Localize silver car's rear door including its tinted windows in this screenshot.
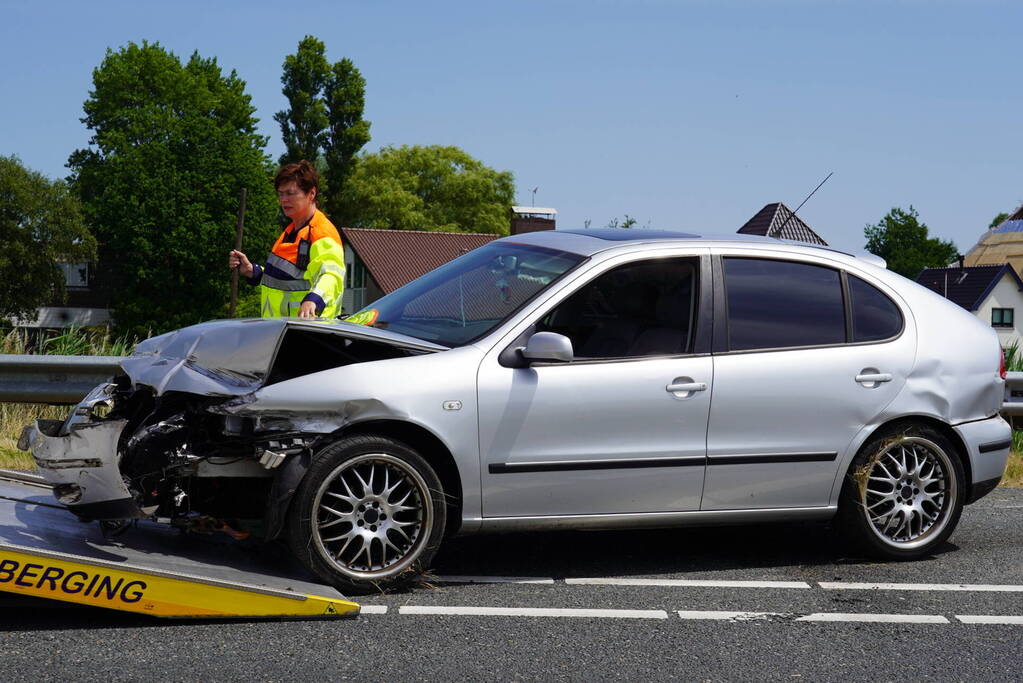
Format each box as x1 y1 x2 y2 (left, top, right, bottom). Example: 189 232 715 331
703 254 916 510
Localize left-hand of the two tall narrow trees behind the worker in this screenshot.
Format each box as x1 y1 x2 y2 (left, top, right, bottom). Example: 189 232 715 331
273 36 330 165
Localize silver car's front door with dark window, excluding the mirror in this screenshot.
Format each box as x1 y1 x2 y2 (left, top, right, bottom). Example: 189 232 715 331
478 257 712 517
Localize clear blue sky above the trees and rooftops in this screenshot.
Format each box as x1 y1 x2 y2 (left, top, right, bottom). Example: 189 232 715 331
0 0 1023 252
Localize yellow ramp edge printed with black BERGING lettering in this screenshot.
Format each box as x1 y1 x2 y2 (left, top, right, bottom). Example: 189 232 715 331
0 544 359 618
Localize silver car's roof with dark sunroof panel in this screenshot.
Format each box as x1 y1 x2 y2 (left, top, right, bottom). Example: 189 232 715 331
500 228 885 268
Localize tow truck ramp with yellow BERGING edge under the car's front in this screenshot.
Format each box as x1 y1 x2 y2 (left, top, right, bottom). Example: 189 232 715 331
0 470 359 619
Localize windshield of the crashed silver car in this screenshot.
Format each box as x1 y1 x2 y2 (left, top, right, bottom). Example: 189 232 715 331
346 242 583 347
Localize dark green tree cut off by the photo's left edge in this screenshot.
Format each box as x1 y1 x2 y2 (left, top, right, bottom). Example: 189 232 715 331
0 156 96 318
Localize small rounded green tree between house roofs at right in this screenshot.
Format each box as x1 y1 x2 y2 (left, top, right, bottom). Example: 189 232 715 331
863 206 959 279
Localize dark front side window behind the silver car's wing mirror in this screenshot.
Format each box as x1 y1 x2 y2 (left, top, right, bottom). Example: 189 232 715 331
537 259 698 359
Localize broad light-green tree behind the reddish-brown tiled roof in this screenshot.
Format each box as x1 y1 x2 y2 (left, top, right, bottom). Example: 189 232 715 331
344 145 515 235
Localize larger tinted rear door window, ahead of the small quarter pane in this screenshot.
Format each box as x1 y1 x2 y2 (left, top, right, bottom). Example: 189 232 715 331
724 258 846 351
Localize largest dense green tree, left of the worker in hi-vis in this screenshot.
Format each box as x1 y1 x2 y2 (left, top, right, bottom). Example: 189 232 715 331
68 42 277 334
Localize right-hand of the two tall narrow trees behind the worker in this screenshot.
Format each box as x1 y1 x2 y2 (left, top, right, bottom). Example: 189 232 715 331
323 58 369 225
